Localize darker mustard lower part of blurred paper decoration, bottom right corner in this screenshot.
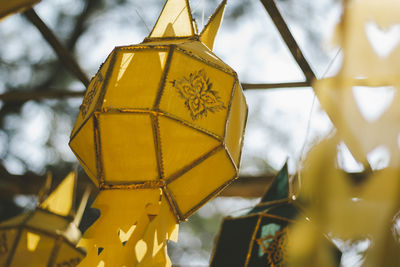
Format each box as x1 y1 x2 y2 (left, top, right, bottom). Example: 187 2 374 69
289 135 400 267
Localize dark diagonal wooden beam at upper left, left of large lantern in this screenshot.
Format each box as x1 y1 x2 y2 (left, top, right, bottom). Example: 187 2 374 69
24 8 89 87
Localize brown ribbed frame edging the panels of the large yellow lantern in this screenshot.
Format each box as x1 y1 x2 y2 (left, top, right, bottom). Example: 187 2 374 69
69 40 248 221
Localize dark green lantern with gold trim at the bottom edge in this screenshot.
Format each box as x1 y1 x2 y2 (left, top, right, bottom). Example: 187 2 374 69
210 164 341 267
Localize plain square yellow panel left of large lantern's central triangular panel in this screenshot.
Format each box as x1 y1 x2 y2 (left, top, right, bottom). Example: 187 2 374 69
99 113 159 182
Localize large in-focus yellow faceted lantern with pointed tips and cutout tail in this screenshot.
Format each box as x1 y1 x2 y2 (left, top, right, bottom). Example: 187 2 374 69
70 0 247 266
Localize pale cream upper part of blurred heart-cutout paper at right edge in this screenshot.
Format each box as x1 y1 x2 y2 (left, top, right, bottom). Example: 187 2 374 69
314 0 400 166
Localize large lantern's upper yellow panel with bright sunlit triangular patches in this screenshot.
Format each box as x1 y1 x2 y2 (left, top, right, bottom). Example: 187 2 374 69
103 50 168 109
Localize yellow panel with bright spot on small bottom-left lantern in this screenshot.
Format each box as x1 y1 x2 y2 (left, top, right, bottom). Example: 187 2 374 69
11 229 54 267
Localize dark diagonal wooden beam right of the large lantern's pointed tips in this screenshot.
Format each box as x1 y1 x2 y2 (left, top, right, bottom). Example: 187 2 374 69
260 0 315 82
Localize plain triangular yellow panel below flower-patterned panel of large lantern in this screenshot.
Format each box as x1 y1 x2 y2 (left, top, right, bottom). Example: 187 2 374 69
158 117 221 179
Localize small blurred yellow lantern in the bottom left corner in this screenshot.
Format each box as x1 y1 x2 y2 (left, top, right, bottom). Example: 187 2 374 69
0 173 86 267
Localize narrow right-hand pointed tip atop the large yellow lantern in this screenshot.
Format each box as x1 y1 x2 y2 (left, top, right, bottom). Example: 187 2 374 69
200 0 227 50
